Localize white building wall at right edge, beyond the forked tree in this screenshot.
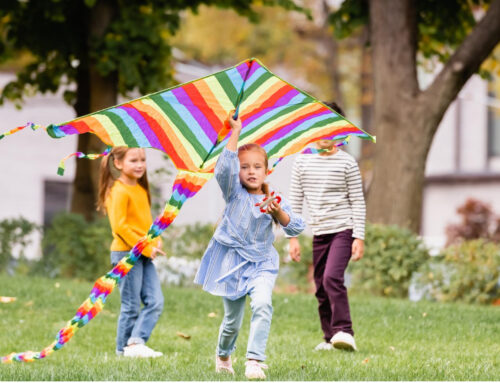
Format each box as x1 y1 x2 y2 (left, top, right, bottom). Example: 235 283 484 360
421 76 500 247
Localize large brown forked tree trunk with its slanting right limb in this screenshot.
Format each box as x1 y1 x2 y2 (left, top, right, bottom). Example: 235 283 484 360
368 0 500 232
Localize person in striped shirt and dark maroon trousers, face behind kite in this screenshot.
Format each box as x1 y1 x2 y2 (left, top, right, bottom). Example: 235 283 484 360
289 103 365 351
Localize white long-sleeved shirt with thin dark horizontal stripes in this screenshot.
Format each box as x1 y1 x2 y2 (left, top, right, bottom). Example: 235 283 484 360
289 149 366 239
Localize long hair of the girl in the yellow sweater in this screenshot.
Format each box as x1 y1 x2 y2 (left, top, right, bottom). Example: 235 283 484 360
97 146 151 214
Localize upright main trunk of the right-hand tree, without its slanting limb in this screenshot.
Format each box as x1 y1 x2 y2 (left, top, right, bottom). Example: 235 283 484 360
367 0 426 231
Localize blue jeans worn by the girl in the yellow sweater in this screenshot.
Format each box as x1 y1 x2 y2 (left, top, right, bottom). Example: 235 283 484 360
111 251 163 355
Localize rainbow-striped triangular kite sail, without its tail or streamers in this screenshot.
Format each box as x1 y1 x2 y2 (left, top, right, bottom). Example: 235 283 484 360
47 59 374 172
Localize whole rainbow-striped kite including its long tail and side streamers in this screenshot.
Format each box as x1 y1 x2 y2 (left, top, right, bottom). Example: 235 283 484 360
0 59 375 363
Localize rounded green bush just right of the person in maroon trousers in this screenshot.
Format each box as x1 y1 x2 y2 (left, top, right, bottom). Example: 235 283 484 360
348 224 429 298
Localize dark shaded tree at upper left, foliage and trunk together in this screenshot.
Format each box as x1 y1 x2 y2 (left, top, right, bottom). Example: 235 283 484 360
0 0 299 220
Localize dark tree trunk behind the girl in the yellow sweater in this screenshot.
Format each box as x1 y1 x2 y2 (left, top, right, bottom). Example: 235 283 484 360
71 2 118 221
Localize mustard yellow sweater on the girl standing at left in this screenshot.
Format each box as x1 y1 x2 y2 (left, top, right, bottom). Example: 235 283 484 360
105 180 158 257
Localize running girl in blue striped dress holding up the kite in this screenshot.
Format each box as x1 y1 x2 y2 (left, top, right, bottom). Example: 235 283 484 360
195 112 305 379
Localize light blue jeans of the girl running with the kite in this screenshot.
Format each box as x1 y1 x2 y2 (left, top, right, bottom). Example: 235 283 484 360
216 278 274 361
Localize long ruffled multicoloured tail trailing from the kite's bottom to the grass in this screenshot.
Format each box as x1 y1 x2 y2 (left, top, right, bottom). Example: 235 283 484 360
0 170 213 363
